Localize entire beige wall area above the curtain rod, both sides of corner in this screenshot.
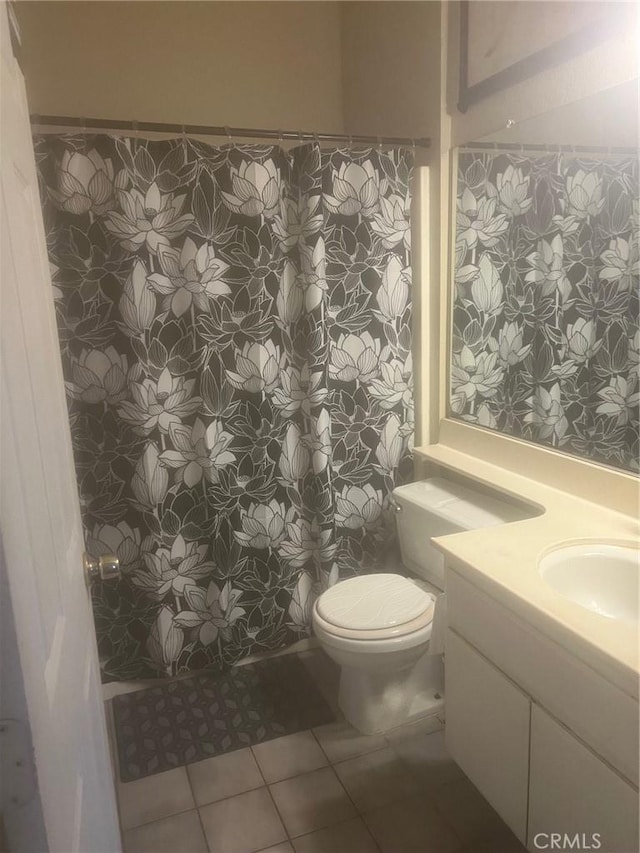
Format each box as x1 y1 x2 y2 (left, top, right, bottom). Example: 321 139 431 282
18 0 440 144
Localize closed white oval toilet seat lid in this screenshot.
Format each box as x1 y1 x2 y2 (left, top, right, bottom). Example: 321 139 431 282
316 574 434 633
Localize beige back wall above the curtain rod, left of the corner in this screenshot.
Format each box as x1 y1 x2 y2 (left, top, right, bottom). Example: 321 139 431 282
17 0 343 132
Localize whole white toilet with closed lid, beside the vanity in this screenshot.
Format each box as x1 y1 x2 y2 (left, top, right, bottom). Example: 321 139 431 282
313 479 526 734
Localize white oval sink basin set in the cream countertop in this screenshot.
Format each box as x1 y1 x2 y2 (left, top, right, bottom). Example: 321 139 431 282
538 544 640 623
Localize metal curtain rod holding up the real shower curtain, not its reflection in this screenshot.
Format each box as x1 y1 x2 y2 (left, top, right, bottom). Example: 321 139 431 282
31 114 431 148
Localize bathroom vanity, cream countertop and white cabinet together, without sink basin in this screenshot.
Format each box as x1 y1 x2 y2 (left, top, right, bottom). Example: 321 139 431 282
424 446 640 853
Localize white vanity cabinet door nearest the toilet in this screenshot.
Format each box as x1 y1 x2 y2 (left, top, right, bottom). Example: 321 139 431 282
445 629 531 843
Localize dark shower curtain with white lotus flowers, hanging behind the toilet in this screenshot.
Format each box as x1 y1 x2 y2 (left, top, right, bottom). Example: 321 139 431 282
36 136 413 679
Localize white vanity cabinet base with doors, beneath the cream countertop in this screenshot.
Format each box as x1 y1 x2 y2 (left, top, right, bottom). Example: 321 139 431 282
445 569 640 853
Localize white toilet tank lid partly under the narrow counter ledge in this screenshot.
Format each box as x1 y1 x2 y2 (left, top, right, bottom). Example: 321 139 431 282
393 477 527 530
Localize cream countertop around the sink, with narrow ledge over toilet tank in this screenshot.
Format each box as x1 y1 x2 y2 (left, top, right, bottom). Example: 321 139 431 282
416 444 640 698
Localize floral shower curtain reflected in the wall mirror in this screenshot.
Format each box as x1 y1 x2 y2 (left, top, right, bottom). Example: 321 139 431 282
450 148 640 470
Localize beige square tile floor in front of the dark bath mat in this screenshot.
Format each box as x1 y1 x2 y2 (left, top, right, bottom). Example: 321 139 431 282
110 651 524 853
